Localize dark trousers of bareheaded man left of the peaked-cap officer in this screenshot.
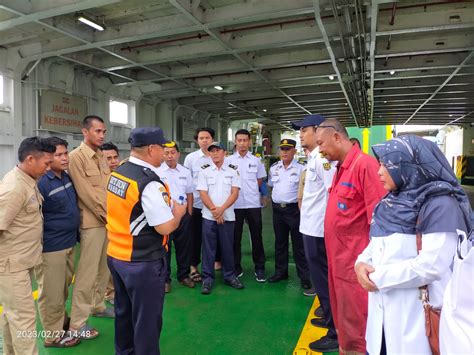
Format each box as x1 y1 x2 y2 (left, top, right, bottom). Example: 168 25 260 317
234 208 265 274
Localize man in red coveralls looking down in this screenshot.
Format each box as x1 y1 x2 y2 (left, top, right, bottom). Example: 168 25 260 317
314 119 386 354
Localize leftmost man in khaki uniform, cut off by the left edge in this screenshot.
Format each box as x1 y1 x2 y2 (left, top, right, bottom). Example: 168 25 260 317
0 137 55 355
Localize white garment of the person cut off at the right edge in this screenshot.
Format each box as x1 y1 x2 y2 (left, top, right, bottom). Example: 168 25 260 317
439 230 474 355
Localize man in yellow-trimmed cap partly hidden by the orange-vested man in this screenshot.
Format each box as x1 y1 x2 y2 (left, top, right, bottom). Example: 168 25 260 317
157 141 195 293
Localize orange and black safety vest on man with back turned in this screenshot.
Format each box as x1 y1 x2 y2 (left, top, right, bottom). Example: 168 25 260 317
107 161 171 262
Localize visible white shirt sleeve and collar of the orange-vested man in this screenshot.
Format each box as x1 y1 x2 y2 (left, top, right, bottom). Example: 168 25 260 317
128 157 174 227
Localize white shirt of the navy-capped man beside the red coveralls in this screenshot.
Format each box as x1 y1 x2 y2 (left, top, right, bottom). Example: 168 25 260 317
300 148 337 238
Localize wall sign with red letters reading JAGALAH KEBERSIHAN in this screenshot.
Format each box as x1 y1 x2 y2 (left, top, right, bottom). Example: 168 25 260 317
39 90 87 133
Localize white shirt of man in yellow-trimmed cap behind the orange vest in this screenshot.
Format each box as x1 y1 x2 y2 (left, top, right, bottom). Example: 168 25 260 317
158 163 194 201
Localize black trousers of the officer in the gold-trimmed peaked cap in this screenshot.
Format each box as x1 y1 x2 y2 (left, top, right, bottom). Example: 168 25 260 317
272 203 310 281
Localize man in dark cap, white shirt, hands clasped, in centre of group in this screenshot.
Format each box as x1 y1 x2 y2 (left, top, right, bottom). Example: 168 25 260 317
197 142 244 295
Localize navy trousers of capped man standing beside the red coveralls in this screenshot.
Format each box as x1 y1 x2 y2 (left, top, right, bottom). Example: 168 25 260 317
303 234 337 339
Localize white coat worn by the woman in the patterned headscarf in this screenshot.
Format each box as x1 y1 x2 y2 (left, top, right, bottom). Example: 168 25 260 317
354 233 458 354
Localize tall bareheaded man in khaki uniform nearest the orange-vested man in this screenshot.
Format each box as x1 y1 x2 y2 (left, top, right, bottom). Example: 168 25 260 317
69 116 114 339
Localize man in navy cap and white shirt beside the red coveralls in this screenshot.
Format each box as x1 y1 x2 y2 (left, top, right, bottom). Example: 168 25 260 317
293 115 338 352
